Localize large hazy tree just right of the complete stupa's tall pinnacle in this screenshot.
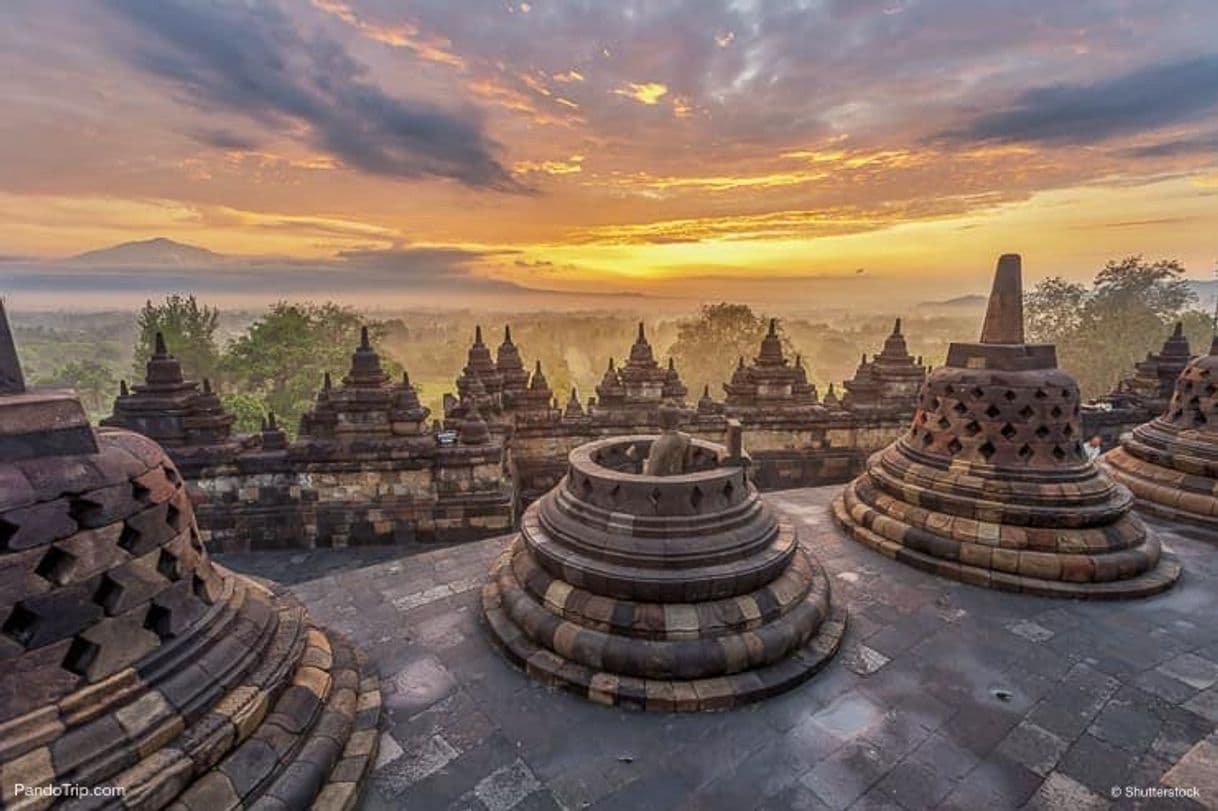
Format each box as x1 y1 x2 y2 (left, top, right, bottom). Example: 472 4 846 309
1024 256 1197 398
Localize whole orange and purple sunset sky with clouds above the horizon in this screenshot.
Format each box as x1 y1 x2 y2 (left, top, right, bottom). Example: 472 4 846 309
0 0 1218 304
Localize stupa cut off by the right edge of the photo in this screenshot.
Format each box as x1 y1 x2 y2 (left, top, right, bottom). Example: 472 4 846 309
1104 336 1218 528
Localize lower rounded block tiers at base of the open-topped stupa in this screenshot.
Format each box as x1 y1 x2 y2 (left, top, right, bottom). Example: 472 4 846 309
482 539 847 712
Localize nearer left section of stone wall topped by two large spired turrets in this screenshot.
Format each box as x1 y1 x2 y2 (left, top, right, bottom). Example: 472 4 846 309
104 335 515 552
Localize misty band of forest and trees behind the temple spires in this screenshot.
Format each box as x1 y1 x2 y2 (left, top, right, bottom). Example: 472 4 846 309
11 256 1213 431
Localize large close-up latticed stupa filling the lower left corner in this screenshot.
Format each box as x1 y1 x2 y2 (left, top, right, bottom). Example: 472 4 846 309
0 303 380 811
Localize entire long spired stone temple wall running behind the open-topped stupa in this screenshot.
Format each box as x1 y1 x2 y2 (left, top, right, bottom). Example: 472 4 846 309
104 323 924 552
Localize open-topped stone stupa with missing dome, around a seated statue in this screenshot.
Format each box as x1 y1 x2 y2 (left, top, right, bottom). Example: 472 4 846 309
482 427 845 711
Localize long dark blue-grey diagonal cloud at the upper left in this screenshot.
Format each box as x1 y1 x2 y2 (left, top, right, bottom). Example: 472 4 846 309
110 0 524 192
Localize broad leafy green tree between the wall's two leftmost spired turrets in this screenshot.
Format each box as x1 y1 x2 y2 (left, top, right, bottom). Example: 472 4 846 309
223 302 401 431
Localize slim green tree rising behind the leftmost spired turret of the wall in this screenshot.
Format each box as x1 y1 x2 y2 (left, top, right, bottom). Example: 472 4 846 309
133 293 220 380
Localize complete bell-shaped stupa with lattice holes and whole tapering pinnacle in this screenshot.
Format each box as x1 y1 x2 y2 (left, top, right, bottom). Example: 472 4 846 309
834 255 1180 598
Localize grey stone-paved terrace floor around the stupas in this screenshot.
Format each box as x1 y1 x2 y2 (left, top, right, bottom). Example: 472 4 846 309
224 488 1218 811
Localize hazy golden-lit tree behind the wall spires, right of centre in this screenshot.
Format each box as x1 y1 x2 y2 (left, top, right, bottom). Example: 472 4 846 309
661 302 793 398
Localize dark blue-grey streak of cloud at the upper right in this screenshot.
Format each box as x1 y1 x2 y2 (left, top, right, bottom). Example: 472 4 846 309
946 54 1218 145
